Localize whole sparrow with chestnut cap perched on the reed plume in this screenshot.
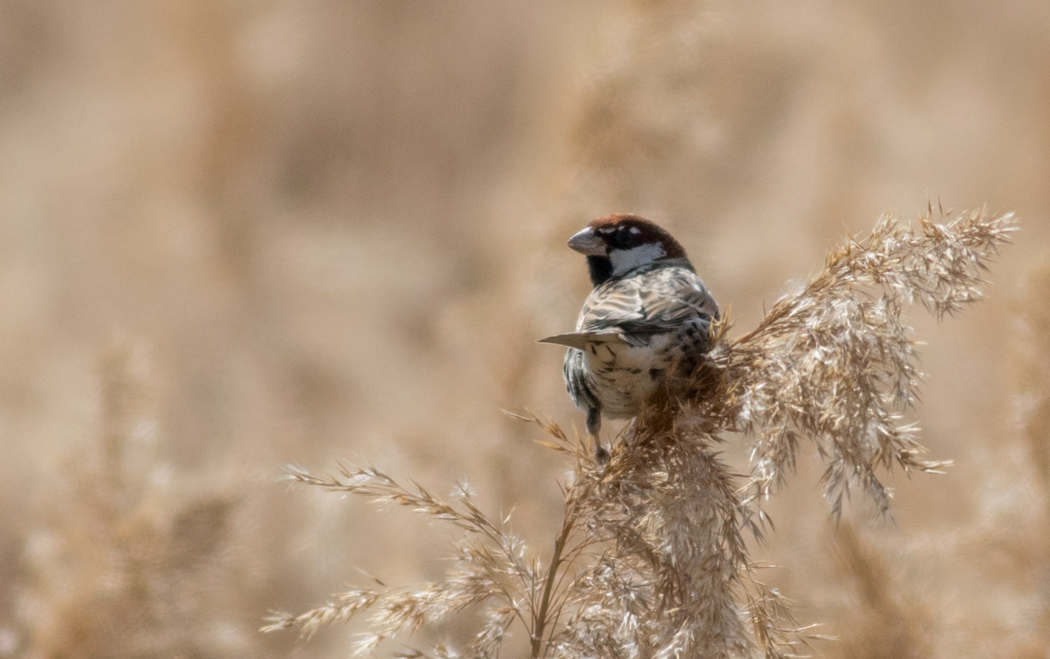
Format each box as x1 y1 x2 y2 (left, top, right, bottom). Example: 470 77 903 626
541 215 718 461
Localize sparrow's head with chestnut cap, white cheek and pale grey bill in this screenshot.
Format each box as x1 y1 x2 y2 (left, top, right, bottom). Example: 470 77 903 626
569 215 691 286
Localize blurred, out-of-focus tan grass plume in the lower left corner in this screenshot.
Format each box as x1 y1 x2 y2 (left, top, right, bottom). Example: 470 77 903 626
22 341 261 659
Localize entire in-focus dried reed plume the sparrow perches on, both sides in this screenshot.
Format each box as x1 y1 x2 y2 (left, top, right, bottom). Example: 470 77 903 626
265 209 1013 658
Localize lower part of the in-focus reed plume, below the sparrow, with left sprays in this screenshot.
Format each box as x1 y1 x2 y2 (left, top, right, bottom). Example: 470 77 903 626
264 418 794 659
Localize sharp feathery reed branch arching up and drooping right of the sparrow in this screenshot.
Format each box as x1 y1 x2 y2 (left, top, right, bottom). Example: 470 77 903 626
700 208 1015 515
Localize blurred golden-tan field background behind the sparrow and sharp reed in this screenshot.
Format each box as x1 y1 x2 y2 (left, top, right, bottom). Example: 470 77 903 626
0 0 1050 658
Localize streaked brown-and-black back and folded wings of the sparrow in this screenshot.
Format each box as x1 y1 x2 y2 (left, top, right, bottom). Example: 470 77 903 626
576 263 718 335
